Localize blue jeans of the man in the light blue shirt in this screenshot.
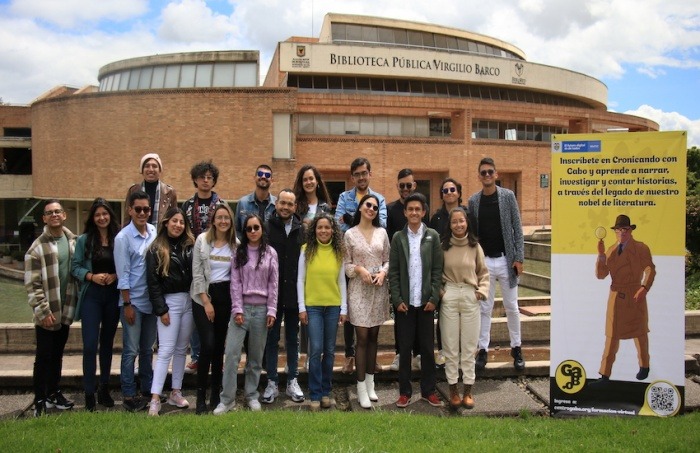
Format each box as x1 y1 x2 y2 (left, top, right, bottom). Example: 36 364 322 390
120 307 157 398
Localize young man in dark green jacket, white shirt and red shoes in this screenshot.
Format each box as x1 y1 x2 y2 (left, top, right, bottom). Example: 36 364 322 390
389 193 443 407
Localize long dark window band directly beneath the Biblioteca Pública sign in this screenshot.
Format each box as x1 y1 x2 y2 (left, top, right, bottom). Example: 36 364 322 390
287 74 592 109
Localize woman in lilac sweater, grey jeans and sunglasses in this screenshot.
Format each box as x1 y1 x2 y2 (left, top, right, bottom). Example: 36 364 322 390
214 214 279 415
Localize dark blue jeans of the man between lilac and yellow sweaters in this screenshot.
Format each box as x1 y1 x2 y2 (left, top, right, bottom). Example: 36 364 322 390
265 305 299 383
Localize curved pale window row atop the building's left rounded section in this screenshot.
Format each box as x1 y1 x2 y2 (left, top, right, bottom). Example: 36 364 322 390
100 62 258 91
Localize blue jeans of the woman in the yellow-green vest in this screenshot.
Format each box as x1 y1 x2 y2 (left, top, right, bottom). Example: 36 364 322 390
306 305 340 401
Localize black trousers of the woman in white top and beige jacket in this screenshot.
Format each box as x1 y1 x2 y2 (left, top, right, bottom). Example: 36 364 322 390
192 282 231 392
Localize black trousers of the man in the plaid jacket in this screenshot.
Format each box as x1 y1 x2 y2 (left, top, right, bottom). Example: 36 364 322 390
34 324 70 401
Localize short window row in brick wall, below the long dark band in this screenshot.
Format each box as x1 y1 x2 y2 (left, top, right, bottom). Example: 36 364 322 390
299 114 452 137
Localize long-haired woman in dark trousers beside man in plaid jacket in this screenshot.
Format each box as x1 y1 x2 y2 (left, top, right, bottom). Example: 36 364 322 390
71 198 119 412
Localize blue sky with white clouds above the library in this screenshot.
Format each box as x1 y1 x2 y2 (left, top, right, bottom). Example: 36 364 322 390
0 0 700 147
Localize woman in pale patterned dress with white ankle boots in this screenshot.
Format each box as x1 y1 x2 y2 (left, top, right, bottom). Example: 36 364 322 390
344 194 389 409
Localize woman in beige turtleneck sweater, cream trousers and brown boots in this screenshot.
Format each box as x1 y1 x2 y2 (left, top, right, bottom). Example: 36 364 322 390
440 207 489 409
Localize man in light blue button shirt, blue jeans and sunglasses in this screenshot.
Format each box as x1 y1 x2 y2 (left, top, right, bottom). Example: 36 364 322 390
114 191 157 412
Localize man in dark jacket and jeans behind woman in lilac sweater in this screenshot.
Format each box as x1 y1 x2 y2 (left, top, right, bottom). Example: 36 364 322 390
261 189 304 404
